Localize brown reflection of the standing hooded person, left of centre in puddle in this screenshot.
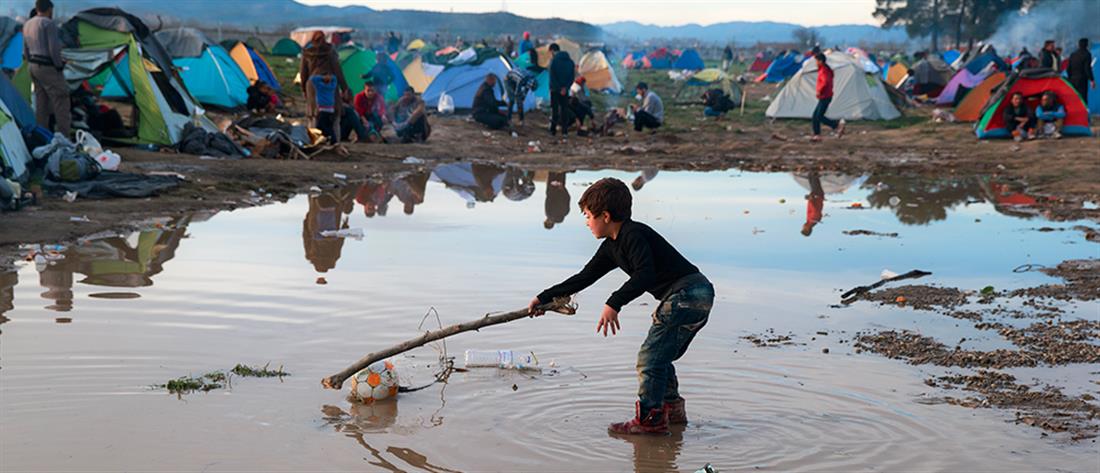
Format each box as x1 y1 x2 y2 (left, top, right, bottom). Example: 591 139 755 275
301 189 354 273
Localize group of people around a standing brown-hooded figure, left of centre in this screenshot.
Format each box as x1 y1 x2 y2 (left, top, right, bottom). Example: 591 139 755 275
298 32 431 143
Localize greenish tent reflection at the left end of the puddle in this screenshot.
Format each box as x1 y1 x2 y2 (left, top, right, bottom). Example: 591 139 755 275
39 216 193 312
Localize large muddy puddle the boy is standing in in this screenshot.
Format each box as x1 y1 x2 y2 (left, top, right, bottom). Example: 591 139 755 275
0 163 1100 472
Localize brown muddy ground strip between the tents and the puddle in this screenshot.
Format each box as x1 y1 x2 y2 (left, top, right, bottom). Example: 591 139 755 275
0 79 1100 268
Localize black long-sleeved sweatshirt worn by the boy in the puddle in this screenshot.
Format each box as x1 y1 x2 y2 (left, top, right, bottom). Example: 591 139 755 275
538 220 699 311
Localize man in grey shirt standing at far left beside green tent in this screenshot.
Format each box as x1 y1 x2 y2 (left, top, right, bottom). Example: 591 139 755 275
23 0 73 136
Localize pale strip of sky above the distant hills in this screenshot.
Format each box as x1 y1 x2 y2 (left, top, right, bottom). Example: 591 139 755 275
297 0 878 26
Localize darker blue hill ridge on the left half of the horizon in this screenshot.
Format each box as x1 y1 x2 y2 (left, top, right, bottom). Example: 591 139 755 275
0 0 603 41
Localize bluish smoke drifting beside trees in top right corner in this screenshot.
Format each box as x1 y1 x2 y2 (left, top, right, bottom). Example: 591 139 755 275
987 0 1100 55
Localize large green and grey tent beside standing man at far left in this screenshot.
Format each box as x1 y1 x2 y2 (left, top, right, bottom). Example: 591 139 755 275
62 8 217 145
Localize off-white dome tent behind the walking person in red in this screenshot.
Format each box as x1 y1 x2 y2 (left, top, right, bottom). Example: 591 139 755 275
766 52 901 120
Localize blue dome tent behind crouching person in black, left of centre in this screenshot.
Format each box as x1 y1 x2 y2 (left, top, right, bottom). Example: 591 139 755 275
422 56 541 110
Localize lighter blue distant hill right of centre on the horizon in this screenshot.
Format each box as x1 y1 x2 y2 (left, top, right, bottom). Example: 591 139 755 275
603 21 909 45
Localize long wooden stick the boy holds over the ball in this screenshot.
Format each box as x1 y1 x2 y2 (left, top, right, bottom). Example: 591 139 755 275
321 297 576 389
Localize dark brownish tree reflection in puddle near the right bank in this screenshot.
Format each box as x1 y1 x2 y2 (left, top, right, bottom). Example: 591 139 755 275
862 174 985 226
